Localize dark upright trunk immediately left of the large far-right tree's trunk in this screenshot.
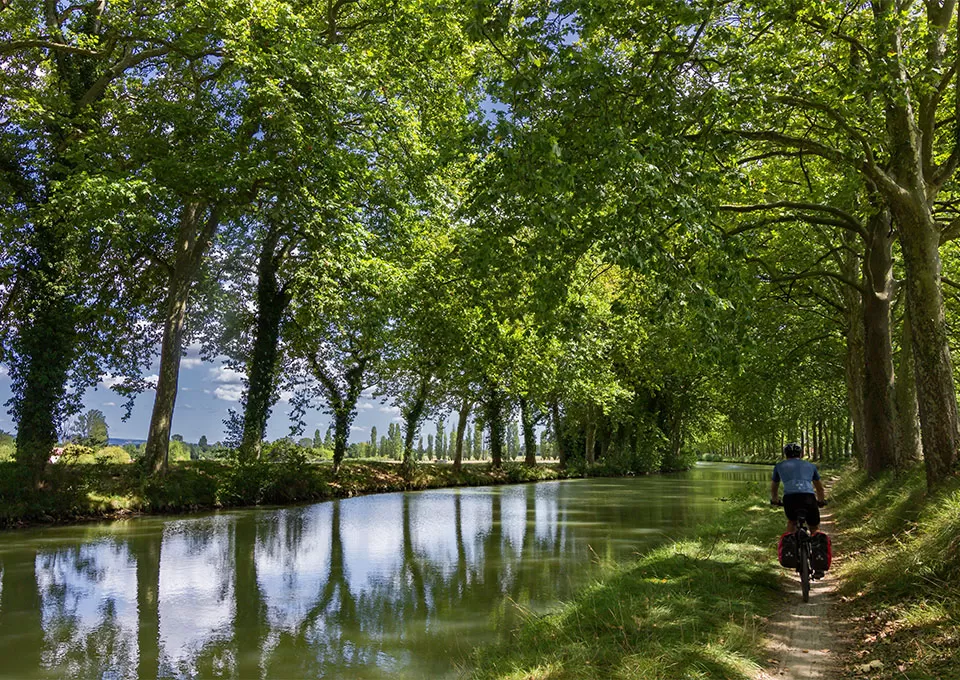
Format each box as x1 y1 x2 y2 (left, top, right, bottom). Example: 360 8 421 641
862 210 897 477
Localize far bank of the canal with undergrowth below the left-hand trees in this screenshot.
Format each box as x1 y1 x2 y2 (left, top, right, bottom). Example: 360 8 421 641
0 458 600 528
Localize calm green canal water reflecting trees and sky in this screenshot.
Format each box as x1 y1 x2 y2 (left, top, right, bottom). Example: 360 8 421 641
0 463 769 679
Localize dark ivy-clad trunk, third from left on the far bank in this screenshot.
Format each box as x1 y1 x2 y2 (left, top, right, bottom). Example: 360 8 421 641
240 225 290 460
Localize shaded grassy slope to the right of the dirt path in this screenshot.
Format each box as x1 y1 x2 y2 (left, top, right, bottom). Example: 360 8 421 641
833 469 960 680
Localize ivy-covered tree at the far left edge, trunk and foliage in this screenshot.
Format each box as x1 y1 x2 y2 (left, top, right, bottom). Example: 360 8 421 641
0 2 221 478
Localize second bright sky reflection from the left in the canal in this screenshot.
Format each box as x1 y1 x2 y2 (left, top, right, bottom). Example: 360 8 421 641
159 517 234 677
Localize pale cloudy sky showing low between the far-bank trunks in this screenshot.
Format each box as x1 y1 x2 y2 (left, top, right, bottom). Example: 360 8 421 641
0 346 428 443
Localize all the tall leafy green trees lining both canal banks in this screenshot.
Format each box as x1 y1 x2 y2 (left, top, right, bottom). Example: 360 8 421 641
0 0 960 485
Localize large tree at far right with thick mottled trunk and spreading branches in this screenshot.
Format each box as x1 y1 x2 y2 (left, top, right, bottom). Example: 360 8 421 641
705 0 960 486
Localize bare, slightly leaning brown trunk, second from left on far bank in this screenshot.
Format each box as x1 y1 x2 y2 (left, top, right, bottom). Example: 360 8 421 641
144 201 220 474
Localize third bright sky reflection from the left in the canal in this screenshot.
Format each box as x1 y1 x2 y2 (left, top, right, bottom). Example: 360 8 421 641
254 503 332 633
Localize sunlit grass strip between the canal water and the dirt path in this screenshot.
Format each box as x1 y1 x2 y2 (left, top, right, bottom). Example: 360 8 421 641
466 489 783 680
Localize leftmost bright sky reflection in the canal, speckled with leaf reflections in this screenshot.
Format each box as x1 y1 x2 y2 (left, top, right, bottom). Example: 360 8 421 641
35 539 138 677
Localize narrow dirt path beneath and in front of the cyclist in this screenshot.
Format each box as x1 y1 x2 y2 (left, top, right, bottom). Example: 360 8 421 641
756 514 840 680
